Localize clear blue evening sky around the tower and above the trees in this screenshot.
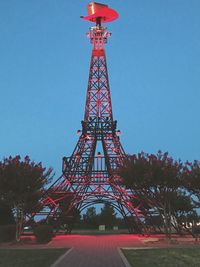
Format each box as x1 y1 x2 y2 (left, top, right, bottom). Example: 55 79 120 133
0 0 200 177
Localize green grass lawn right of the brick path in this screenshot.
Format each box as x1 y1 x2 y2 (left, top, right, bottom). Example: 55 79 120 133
122 247 200 267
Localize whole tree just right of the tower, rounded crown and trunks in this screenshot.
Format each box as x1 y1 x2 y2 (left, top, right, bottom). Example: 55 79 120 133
119 151 183 238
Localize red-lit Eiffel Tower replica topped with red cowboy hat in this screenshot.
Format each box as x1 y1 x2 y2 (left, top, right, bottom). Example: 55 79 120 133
34 2 148 233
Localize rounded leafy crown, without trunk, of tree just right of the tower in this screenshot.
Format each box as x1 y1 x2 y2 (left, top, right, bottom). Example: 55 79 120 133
119 151 183 192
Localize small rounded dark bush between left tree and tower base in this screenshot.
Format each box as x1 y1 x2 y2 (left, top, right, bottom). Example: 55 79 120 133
34 225 53 244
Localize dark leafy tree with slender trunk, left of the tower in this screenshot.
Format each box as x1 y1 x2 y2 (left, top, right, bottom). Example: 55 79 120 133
0 156 53 241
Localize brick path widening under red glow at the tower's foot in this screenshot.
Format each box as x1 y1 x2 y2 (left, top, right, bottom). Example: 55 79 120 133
49 235 144 267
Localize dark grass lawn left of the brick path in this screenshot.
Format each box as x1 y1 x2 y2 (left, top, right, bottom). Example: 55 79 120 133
0 249 67 267
